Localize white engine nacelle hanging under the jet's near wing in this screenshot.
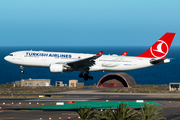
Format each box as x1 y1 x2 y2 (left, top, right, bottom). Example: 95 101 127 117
49 64 73 72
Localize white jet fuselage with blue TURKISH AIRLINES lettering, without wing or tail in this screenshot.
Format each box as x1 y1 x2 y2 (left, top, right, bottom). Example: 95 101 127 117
4 51 162 71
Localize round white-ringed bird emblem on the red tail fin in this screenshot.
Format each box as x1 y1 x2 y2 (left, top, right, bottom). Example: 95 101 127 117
150 40 169 58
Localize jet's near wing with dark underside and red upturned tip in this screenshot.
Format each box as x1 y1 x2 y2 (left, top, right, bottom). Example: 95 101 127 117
66 51 103 67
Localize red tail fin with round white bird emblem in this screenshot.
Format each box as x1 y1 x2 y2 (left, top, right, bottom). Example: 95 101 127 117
136 33 176 58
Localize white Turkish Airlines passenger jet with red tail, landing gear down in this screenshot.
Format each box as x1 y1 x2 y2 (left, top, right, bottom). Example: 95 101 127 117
4 32 175 81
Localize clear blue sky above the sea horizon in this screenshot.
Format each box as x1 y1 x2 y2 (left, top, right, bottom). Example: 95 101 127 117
0 0 180 46
